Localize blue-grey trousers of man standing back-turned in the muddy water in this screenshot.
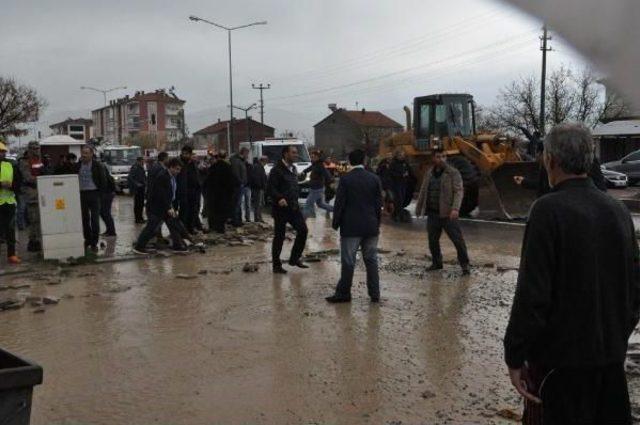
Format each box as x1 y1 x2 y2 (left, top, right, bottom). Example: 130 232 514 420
336 236 380 298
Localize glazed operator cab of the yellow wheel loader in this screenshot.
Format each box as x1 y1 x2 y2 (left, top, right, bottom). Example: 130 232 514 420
413 94 475 149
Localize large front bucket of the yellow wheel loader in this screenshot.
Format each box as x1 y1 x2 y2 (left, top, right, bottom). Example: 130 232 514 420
478 161 540 220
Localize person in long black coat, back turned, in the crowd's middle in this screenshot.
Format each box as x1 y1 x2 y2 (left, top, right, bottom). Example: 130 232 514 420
205 151 238 233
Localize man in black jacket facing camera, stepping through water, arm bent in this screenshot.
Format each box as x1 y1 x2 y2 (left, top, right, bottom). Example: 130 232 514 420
267 145 309 274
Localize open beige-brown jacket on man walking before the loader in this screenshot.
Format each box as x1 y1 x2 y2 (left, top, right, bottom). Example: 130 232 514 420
416 164 464 218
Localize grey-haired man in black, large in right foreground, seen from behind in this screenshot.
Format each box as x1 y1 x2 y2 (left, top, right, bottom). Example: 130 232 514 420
504 124 640 425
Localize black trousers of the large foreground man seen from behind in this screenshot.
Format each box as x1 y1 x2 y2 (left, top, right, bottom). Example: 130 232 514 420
541 363 631 425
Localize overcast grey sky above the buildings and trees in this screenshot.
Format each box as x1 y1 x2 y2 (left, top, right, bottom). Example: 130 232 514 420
0 0 584 136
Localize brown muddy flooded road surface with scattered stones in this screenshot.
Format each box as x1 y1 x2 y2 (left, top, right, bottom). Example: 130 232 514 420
0 210 637 425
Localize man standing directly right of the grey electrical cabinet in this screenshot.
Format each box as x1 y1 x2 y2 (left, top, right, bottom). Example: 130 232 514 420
76 145 106 252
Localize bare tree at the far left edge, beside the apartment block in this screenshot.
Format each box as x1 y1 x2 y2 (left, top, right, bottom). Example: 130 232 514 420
0 77 46 131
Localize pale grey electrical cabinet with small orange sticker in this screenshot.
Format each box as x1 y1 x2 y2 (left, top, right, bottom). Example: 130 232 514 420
38 174 84 260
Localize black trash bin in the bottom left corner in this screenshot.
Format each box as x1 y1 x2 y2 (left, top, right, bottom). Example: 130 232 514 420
0 348 42 425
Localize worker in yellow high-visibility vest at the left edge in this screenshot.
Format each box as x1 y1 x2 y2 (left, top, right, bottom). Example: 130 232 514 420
0 141 20 264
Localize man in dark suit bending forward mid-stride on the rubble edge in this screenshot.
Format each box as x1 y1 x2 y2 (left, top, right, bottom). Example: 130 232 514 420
133 158 186 255
